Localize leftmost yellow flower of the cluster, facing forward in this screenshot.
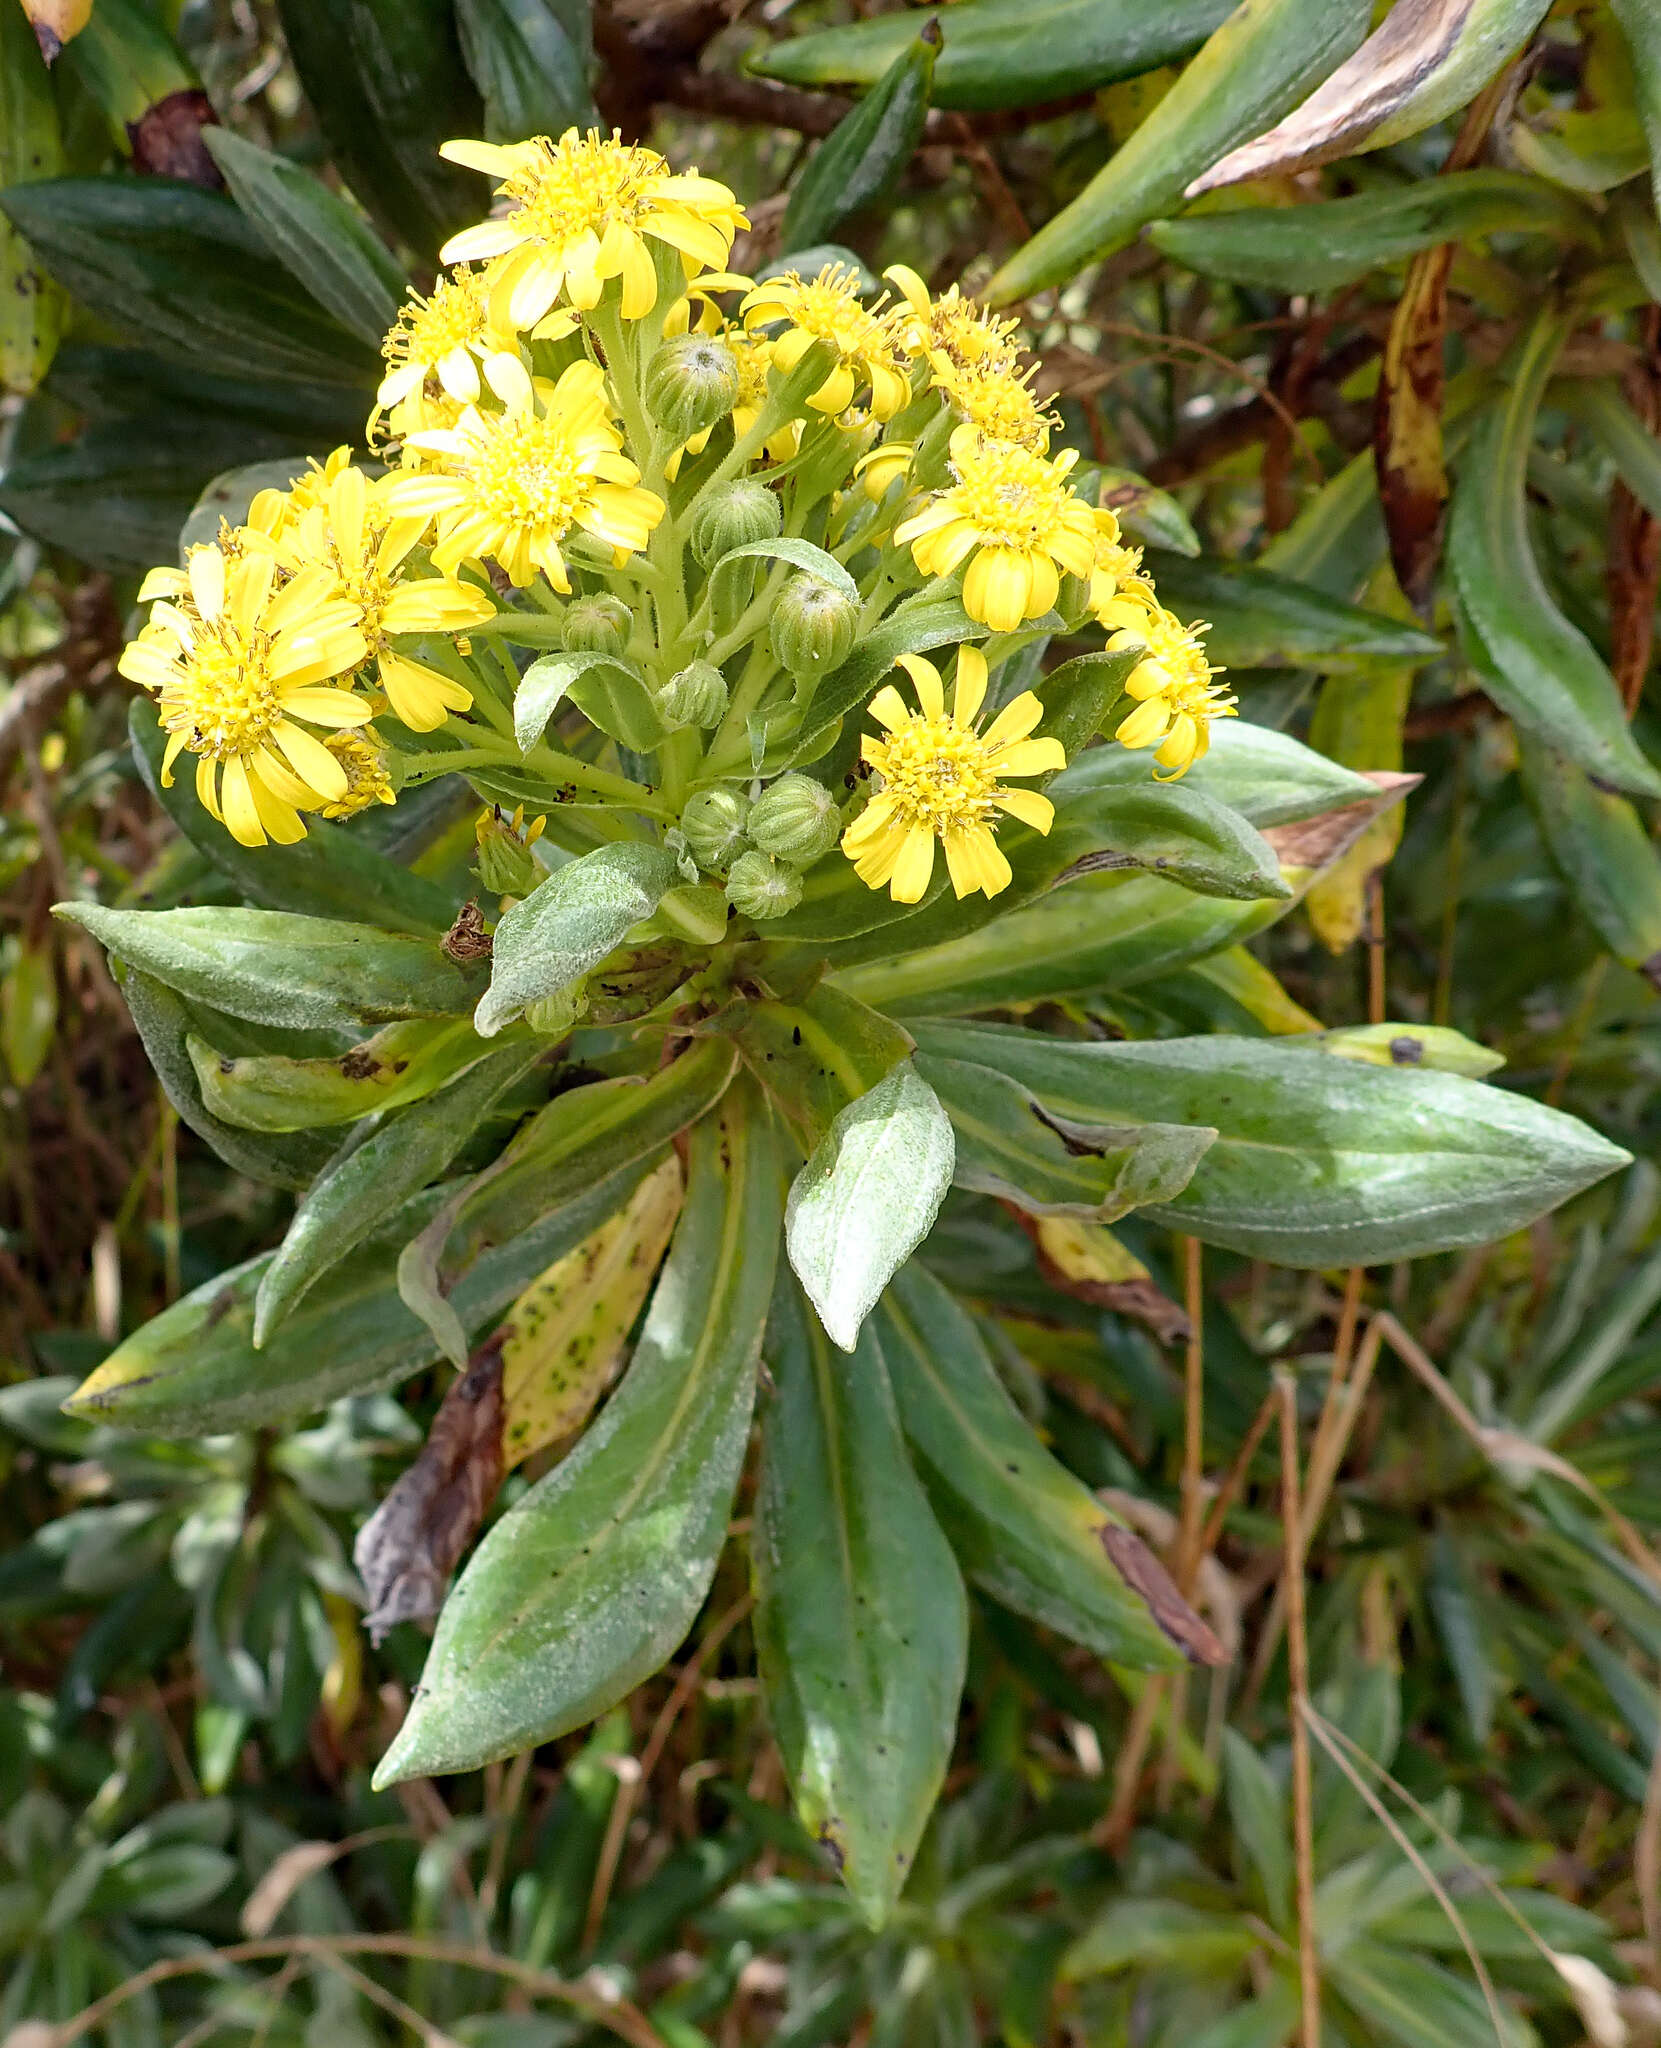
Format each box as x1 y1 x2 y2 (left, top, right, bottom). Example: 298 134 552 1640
121 547 371 846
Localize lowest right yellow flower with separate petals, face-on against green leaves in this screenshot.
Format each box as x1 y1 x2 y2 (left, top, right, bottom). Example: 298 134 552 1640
842 647 1067 903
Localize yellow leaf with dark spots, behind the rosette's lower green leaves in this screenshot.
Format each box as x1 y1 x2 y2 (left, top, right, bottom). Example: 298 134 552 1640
498 1153 686 1470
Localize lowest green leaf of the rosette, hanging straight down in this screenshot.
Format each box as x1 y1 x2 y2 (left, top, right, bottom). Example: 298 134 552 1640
752 1278 969 1927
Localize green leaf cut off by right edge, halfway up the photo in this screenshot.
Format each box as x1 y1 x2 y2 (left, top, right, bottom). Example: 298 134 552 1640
1520 735 1661 987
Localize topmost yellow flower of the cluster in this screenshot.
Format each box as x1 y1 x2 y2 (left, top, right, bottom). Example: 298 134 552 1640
438 129 750 330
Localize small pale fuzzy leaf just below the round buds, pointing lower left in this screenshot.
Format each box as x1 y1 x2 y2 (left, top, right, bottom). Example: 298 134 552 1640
473 844 680 1038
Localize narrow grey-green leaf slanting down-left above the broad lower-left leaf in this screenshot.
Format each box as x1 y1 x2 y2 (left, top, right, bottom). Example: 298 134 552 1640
254 1042 543 1350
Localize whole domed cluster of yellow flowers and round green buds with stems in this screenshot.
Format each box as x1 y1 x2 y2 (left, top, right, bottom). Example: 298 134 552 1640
121 129 1233 897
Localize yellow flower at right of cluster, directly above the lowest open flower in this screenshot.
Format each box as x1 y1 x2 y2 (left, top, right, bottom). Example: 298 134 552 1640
895 426 1102 633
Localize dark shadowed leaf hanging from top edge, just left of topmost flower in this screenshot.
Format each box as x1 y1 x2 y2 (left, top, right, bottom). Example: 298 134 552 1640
276 0 485 260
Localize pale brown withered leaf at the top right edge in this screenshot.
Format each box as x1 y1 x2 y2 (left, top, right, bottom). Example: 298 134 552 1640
1188 0 1550 199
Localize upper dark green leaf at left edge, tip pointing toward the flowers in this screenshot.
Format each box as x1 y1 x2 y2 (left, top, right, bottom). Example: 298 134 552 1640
0 178 377 389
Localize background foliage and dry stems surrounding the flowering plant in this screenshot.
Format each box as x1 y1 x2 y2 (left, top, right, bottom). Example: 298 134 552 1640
0 0 1661 2048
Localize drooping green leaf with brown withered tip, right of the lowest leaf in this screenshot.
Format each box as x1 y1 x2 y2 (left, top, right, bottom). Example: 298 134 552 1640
872 1266 1221 1671
